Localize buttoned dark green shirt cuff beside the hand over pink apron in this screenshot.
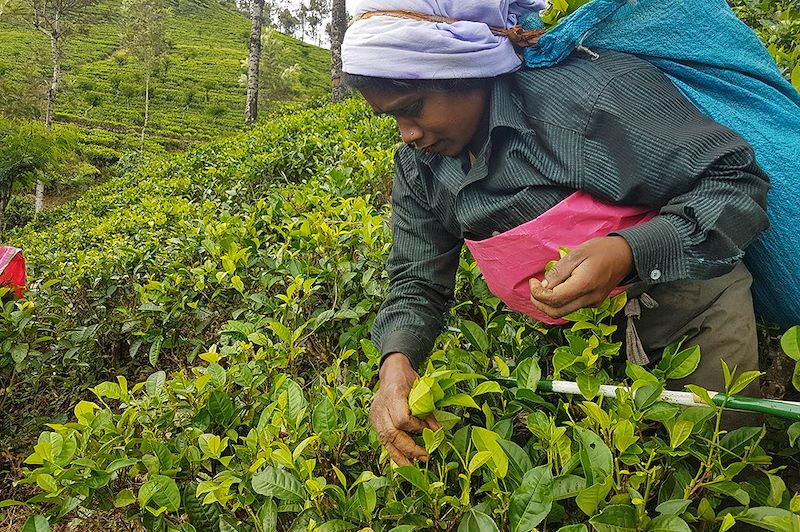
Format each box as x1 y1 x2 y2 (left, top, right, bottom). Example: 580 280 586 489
611 216 687 285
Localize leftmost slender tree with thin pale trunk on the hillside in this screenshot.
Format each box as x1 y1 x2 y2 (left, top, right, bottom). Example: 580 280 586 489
17 0 98 213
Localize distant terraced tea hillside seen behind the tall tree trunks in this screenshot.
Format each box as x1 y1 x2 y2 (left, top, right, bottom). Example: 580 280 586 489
0 0 330 155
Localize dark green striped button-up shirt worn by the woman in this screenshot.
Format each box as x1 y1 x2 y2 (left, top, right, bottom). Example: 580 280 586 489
373 51 769 367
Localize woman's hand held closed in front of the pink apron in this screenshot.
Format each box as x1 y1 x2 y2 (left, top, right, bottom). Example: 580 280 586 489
530 236 634 318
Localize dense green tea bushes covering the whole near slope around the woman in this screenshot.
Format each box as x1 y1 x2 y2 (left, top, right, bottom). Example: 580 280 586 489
0 4 800 532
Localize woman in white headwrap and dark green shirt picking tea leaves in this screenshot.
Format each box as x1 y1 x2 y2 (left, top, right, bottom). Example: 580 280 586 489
342 0 769 464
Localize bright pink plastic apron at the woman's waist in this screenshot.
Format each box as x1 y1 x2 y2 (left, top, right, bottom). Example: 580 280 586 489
466 191 656 325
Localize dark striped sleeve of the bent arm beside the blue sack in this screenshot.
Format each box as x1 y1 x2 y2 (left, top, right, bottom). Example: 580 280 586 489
582 67 769 284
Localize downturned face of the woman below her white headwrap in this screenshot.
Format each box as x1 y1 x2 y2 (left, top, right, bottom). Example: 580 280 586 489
362 89 489 157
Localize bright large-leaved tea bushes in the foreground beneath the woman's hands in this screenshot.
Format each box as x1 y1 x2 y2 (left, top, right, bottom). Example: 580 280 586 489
9 288 800 531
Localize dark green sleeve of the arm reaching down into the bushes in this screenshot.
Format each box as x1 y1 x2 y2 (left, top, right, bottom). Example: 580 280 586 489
372 147 463 369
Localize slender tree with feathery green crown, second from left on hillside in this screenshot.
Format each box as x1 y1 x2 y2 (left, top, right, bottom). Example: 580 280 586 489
122 0 168 153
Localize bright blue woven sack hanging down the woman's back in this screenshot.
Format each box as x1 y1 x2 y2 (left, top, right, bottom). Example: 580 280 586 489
523 0 800 326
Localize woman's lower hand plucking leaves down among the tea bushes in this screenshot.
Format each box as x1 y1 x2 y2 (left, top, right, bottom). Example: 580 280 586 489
369 353 440 465
